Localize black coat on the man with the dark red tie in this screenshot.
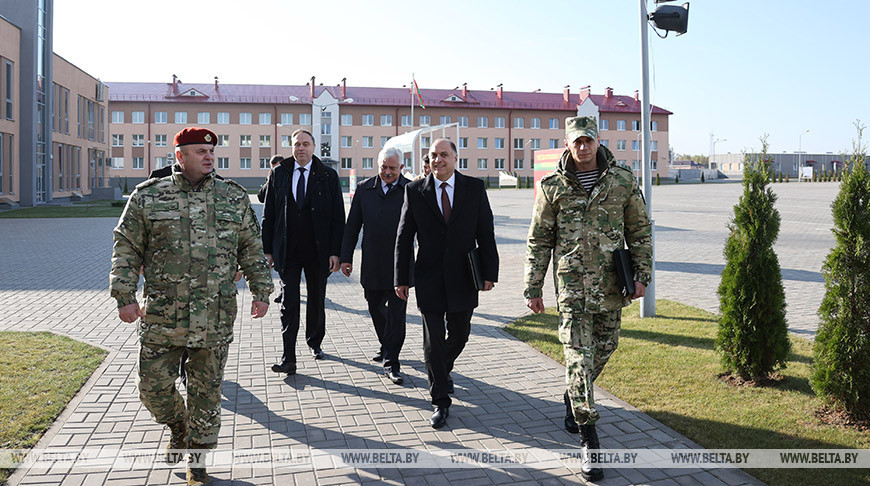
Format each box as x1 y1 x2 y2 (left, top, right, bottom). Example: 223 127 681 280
394 171 498 313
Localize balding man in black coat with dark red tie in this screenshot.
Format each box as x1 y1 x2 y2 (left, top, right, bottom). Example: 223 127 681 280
394 139 498 429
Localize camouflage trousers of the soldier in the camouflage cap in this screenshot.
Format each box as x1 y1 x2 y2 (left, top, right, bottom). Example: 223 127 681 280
559 309 622 425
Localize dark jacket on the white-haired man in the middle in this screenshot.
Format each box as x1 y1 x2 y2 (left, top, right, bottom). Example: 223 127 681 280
341 176 413 290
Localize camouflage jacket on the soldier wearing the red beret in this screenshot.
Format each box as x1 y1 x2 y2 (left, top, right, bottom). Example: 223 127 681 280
109 165 272 348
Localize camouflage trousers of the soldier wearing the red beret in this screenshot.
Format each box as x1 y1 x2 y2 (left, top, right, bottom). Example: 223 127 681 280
136 343 229 449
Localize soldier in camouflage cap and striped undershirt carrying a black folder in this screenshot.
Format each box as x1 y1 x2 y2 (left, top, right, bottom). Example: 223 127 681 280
525 116 652 480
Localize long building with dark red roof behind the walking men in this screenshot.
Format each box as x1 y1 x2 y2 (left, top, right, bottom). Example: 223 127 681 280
108 76 671 188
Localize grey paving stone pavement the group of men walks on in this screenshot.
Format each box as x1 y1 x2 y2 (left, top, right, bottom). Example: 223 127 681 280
0 180 836 485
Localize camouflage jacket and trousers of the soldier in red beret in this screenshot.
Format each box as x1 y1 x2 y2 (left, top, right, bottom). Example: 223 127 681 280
110 165 272 448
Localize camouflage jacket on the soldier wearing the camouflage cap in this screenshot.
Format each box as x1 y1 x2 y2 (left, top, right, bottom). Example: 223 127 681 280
524 146 652 314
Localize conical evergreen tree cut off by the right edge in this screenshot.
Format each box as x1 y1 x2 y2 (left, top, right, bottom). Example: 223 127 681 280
810 121 870 418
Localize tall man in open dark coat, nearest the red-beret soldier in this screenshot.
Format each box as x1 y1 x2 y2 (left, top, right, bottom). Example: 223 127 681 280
263 129 344 375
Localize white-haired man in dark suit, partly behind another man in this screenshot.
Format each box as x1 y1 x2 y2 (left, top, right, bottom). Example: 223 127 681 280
341 148 410 385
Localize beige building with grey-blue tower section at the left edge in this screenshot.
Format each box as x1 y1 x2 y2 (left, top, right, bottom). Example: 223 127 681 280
0 0 109 207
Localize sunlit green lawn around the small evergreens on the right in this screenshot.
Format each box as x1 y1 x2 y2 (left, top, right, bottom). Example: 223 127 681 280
506 300 870 485
